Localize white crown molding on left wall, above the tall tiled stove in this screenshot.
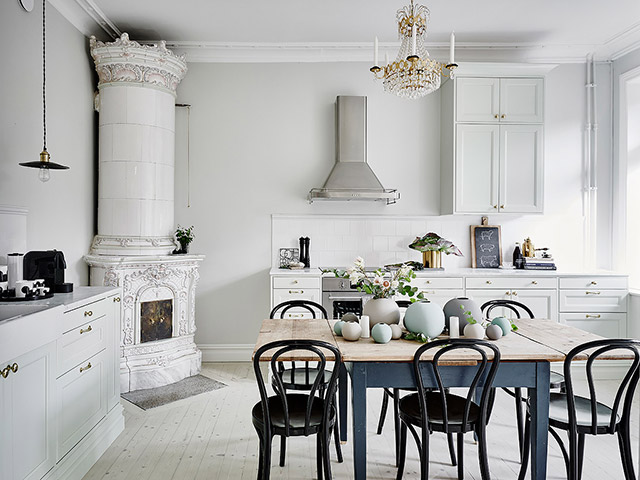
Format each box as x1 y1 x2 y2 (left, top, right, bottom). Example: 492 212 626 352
49 0 122 40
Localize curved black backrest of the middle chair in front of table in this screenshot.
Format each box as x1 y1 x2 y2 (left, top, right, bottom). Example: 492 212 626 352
413 338 500 441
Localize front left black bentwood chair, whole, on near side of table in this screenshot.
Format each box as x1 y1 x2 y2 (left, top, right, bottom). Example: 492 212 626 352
251 340 342 480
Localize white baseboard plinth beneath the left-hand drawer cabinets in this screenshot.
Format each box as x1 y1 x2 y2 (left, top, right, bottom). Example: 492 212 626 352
43 402 124 480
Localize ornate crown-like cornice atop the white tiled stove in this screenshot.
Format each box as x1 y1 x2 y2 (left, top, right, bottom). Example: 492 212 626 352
89 33 187 96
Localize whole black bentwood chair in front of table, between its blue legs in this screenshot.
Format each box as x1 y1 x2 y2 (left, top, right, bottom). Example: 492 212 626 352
396 338 500 480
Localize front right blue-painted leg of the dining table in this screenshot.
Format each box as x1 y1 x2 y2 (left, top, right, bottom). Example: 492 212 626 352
529 362 550 480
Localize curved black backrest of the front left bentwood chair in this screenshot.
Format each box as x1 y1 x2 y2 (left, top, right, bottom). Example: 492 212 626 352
253 340 342 438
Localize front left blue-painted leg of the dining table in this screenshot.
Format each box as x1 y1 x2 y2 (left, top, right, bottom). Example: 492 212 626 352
351 363 367 480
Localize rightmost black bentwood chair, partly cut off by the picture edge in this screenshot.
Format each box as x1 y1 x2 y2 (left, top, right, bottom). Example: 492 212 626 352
518 339 640 480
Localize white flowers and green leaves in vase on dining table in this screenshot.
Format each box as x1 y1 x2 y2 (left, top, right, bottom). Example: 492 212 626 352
326 257 424 302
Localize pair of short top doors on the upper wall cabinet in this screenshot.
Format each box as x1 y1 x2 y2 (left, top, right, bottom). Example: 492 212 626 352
456 77 544 123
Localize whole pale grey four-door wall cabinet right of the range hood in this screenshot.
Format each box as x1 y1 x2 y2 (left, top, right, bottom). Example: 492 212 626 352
440 68 544 215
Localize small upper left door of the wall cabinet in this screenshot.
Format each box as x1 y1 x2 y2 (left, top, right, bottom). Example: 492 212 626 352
456 78 500 123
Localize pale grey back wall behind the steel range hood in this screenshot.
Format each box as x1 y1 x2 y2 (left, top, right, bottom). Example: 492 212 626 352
175 63 586 344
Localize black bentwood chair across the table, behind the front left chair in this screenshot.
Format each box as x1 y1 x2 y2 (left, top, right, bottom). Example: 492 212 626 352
269 300 343 467
